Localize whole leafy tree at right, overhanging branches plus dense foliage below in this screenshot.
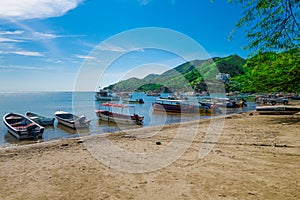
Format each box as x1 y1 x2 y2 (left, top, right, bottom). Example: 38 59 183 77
228 0 300 93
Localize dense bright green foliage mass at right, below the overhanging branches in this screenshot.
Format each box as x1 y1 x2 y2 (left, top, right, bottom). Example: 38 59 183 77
232 50 300 93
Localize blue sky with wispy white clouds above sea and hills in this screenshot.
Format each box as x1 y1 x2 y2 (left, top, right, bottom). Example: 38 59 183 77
0 0 248 92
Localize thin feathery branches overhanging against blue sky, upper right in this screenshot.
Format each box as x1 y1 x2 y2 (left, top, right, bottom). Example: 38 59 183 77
228 0 300 52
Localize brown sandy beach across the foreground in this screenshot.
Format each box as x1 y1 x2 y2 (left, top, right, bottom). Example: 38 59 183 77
0 105 300 199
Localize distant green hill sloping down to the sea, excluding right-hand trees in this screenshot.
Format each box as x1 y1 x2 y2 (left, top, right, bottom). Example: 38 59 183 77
107 55 246 92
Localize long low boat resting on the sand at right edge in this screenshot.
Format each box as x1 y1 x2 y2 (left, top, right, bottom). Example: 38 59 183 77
256 106 300 115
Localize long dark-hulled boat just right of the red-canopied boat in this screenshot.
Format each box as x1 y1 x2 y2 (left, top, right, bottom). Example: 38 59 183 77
152 98 197 113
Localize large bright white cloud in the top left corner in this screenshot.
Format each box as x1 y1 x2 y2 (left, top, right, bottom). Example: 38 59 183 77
0 0 83 20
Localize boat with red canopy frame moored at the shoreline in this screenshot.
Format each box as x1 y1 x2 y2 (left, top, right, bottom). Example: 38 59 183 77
95 103 144 125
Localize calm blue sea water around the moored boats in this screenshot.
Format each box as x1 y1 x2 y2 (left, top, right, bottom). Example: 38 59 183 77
0 92 256 147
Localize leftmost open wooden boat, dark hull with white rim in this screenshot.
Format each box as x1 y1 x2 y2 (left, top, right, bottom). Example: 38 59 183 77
3 112 44 140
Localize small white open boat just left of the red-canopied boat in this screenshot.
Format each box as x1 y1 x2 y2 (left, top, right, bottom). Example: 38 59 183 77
54 111 91 129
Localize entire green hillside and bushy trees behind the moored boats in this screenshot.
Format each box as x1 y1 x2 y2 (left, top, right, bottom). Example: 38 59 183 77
104 49 300 93
